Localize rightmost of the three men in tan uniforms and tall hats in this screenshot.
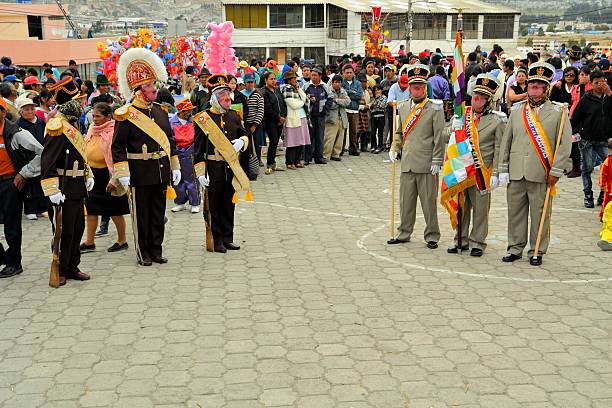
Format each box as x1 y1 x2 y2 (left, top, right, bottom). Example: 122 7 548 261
499 62 572 266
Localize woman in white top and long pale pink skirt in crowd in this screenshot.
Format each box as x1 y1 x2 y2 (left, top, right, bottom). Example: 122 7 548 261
282 71 310 170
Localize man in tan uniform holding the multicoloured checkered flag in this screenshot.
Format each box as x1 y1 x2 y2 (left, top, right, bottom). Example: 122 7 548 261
447 74 507 256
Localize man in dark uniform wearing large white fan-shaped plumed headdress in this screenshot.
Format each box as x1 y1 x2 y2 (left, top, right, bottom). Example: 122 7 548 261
112 48 181 266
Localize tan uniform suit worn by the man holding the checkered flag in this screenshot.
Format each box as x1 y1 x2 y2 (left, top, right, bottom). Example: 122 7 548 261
455 112 507 251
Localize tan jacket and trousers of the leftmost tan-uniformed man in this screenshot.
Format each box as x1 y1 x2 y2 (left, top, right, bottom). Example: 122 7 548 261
395 99 444 242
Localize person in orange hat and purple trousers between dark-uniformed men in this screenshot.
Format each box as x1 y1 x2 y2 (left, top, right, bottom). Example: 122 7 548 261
170 99 200 214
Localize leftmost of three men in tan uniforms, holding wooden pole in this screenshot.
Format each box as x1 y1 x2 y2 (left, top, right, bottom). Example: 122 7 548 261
387 64 444 249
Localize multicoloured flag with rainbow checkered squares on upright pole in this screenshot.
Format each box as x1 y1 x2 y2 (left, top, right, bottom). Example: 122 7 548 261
440 32 476 229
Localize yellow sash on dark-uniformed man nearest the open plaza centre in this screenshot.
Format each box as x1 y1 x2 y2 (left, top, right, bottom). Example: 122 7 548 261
194 112 253 204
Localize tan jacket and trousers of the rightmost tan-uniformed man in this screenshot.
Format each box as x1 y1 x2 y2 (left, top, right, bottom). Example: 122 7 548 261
499 101 572 256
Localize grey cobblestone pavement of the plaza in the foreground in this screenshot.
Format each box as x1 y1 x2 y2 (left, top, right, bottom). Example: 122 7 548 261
0 154 612 408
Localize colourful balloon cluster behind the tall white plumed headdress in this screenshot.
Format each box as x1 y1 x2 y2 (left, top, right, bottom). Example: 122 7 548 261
97 27 208 88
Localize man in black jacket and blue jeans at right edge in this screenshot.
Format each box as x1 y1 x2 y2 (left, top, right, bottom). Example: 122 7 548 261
571 71 612 208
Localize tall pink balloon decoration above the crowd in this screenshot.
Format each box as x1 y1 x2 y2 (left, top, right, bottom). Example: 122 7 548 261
204 21 238 74
